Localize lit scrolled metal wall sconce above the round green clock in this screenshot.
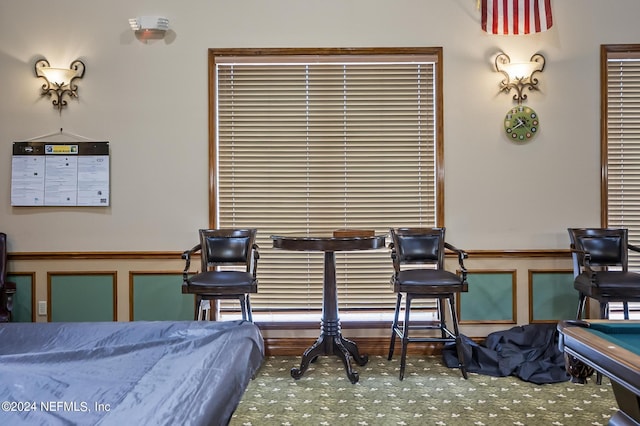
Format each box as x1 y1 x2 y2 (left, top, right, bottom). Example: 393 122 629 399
495 53 545 105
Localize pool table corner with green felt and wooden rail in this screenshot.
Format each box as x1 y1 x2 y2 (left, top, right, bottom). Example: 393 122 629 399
558 320 640 425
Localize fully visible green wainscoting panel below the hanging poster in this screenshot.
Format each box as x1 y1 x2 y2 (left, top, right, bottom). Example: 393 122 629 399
49 272 116 322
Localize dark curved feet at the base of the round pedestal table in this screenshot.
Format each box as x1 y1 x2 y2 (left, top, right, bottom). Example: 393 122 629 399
291 333 369 384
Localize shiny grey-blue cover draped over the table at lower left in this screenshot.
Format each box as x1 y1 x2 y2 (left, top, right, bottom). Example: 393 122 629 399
0 321 264 426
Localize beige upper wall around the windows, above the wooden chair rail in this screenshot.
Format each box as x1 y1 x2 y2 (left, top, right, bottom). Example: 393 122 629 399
0 0 640 252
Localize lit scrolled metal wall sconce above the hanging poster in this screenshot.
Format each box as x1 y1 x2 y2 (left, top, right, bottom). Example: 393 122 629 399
35 59 84 112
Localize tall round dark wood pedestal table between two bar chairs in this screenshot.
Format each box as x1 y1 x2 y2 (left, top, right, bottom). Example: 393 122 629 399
271 232 386 384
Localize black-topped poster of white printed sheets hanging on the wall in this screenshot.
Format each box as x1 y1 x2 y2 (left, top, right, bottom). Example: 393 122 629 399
11 141 110 207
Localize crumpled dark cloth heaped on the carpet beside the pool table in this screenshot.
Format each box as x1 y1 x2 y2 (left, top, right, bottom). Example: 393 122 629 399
442 324 571 384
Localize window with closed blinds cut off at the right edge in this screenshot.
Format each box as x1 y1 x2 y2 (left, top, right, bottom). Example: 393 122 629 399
603 46 640 271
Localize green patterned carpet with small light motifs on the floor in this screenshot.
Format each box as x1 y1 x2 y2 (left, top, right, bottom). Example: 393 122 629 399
230 356 618 426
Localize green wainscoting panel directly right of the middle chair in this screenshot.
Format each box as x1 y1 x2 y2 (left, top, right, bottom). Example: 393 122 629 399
460 270 516 324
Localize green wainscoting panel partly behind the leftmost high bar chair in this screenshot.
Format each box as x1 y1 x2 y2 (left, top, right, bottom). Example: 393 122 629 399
131 272 195 321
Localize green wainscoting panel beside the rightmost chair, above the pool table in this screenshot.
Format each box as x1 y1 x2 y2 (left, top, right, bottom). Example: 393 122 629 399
529 271 578 323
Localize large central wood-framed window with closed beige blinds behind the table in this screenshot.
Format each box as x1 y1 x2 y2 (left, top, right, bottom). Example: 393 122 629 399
210 49 442 312
